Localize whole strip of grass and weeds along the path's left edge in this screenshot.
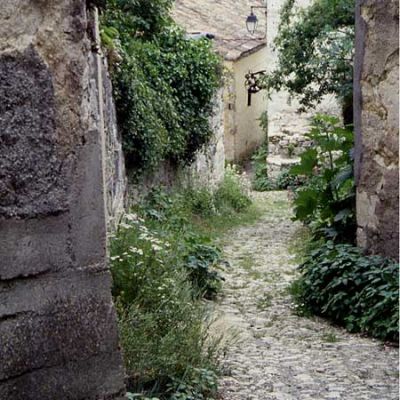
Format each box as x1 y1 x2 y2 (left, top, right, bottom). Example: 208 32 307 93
110 169 251 400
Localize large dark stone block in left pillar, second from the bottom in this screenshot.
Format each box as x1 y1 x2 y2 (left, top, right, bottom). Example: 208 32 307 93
0 273 118 381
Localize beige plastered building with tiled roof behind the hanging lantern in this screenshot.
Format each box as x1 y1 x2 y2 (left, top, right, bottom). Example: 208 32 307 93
173 0 268 161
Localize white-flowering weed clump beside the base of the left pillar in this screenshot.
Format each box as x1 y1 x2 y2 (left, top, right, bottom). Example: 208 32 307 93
110 214 219 395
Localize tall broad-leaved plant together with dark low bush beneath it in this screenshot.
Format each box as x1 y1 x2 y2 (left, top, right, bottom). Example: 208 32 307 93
284 115 399 340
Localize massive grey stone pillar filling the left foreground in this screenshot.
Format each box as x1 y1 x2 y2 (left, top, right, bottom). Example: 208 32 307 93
0 0 124 400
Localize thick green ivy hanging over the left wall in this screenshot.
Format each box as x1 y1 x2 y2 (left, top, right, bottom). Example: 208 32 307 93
102 0 220 174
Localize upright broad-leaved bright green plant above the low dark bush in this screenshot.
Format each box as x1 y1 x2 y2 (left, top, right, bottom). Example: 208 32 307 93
290 114 356 242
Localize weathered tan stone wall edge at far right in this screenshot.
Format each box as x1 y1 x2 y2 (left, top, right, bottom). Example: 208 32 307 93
355 0 399 259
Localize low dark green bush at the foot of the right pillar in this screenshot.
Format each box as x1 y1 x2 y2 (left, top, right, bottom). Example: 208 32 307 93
291 242 399 341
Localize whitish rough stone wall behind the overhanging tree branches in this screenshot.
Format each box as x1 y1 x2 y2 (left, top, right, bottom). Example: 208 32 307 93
267 0 341 159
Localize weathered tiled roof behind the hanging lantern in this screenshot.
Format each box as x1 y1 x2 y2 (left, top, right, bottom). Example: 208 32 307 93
172 0 266 60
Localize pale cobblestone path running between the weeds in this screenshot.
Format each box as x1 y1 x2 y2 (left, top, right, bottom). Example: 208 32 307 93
217 192 398 400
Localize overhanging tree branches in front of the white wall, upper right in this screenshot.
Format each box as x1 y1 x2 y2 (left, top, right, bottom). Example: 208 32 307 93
265 0 355 115
